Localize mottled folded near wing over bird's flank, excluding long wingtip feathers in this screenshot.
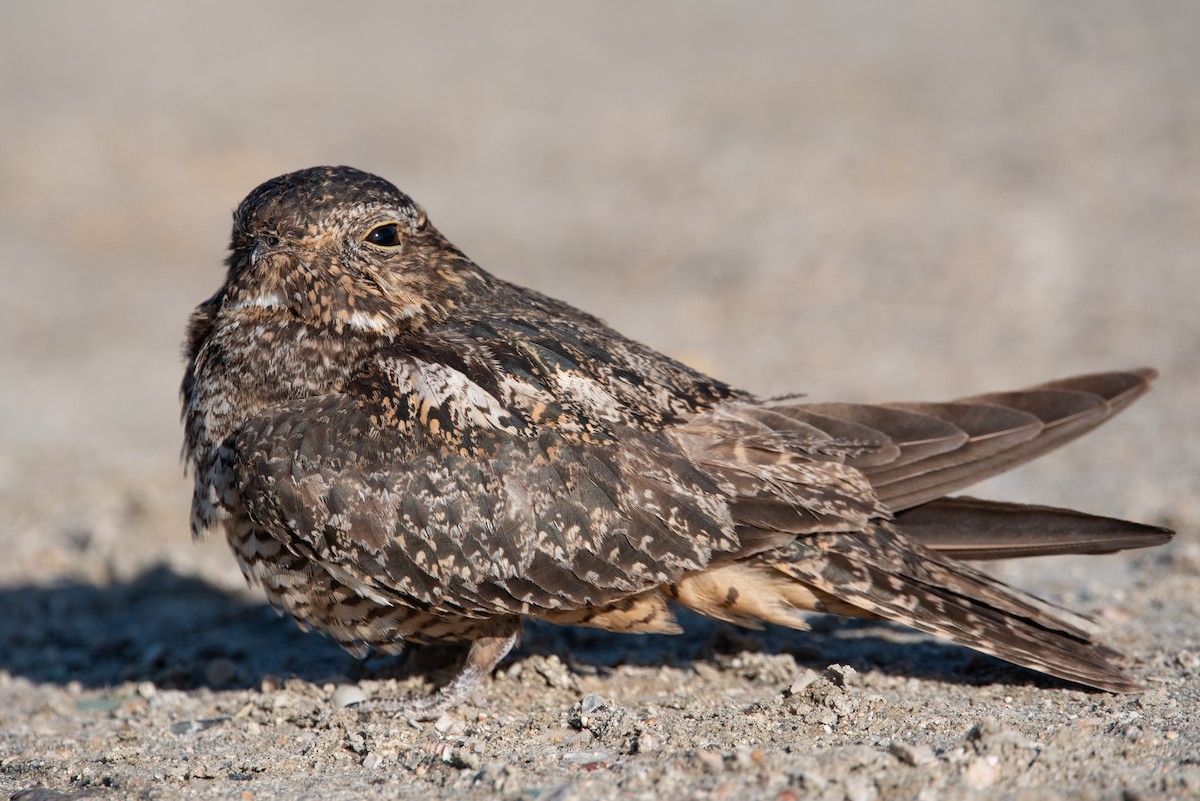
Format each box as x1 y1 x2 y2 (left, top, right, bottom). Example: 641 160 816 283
232 349 738 618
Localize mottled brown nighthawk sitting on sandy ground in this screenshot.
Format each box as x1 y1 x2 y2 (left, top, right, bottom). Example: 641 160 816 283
182 167 1171 716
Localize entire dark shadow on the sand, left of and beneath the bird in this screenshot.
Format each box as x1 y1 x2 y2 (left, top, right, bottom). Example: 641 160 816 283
0 566 1073 689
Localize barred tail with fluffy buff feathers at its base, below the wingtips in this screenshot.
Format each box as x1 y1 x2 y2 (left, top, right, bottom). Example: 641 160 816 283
667 524 1142 693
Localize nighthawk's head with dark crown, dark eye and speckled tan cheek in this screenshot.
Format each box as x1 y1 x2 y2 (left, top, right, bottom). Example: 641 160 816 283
221 167 469 333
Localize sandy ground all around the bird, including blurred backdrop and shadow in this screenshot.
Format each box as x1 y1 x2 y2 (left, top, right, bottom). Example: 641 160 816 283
0 0 1200 801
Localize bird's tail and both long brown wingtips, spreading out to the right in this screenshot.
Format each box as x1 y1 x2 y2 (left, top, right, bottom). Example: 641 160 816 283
668 369 1172 692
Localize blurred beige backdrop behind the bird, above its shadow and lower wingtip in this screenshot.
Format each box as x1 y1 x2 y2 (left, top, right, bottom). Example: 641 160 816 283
0 0 1200 597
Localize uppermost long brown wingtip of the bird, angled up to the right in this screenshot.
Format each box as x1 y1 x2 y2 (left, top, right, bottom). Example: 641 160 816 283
673 369 1154 536
